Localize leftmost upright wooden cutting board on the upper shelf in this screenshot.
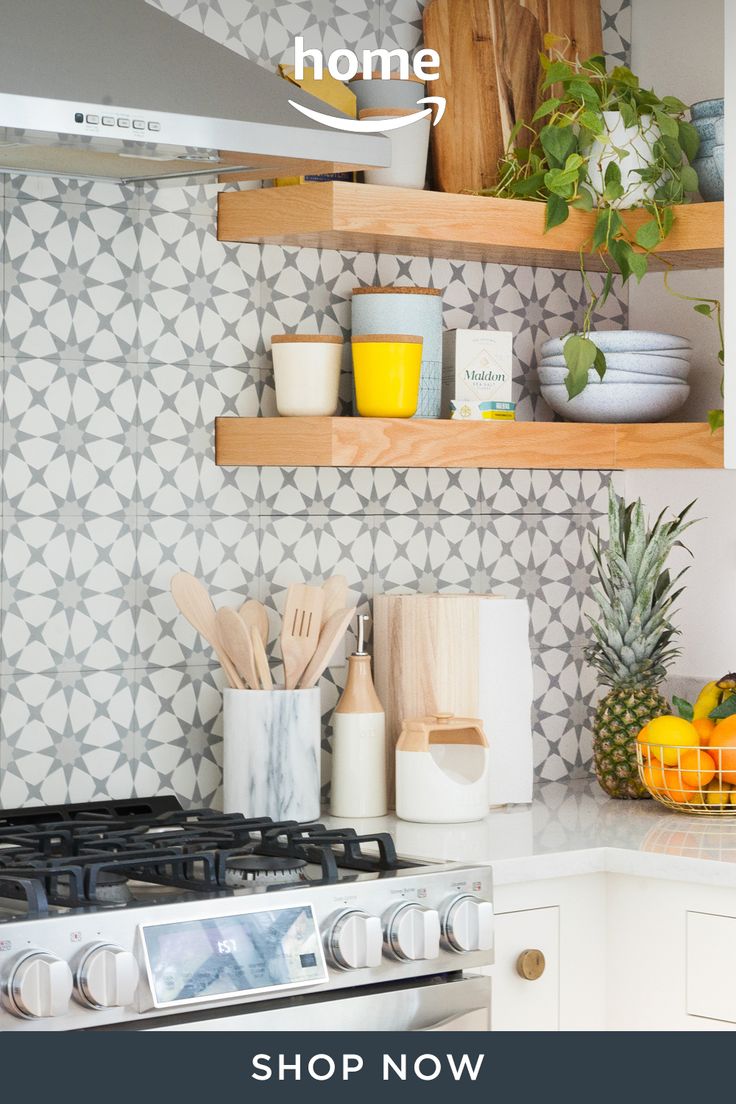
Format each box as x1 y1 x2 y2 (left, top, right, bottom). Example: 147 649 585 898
424 0 504 192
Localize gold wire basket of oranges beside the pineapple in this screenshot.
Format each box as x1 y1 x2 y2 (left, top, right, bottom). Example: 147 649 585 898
637 740 736 817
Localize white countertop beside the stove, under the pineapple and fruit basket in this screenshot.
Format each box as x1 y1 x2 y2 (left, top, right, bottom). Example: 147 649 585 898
327 779 736 888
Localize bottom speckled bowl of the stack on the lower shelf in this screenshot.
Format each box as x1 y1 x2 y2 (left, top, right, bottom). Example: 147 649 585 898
541 383 690 422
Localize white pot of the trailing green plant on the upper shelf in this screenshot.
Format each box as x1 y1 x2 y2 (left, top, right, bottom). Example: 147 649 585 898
588 112 661 210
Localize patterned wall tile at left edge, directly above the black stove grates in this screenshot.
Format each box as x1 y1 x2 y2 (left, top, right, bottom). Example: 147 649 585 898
0 671 136 808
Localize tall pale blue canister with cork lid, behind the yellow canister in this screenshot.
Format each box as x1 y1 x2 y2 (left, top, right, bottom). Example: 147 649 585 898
352 287 442 417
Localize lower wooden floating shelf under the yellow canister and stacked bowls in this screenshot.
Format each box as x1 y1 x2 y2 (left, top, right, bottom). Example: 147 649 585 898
215 417 723 469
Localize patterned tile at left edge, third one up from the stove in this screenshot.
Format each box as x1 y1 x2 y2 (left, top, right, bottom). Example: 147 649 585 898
3 358 138 516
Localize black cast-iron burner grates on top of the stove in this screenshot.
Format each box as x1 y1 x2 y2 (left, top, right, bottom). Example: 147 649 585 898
0 797 415 921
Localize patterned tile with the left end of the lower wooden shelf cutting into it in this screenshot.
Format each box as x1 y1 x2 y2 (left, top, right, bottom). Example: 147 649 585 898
138 363 260 516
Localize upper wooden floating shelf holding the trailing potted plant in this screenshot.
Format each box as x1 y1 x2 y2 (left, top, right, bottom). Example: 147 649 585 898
217 181 724 270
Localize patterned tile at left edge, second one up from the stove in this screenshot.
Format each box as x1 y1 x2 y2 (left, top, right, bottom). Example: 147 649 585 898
0 516 137 673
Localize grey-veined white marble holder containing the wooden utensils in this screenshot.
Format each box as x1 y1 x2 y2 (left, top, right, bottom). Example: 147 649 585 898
223 687 321 820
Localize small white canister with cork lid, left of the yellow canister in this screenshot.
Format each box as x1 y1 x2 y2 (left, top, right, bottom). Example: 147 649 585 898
271 333 343 417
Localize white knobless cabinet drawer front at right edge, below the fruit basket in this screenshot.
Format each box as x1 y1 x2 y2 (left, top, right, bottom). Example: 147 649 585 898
686 912 736 1023
